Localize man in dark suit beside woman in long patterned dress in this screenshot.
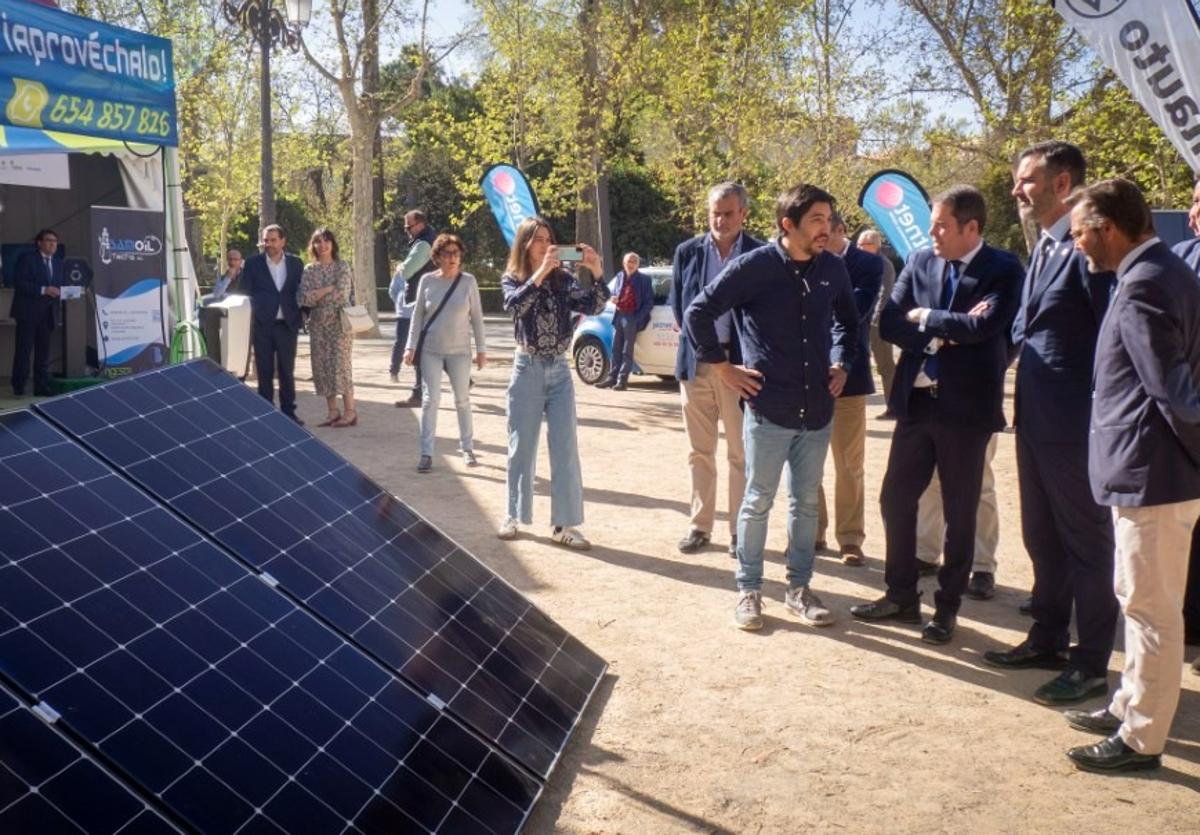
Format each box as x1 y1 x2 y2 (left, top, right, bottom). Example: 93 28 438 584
239 223 304 423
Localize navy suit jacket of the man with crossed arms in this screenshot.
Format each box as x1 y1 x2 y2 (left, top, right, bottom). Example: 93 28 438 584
880 244 1025 424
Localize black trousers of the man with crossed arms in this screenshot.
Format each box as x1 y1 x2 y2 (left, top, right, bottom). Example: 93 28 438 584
880 389 992 614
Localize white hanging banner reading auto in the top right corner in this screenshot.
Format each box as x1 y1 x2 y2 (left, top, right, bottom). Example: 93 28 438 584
1055 0 1200 172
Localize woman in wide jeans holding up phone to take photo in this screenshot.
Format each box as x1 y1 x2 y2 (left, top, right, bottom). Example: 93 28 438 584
498 217 610 549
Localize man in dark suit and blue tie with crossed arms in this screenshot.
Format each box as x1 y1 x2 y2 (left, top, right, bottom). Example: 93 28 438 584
851 186 1024 643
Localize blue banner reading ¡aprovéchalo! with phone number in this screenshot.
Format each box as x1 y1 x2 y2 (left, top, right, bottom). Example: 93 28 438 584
0 0 179 145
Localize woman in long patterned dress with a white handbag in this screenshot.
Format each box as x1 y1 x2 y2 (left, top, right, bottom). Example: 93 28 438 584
300 229 359 427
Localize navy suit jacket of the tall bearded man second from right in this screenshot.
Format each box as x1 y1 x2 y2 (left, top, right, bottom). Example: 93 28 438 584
1013 225 1116 444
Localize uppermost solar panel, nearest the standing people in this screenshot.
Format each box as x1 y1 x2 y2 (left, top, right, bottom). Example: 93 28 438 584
37 360 605 777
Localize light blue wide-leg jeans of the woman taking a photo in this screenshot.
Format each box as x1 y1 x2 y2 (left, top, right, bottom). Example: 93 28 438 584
508 353 583 528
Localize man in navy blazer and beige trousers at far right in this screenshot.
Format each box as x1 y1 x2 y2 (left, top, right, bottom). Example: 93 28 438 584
1064 180 1200 773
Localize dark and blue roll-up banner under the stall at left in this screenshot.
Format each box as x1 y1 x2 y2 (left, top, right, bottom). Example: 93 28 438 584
91 206 167 377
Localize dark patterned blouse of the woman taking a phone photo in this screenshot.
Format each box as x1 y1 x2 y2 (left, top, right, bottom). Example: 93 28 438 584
500 269 611 359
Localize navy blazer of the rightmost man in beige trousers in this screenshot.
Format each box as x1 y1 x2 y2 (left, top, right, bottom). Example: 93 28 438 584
1087 241 1200 507
